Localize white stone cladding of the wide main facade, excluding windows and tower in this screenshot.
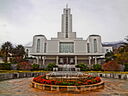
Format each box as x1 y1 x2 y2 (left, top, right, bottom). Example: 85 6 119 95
26 35 107 55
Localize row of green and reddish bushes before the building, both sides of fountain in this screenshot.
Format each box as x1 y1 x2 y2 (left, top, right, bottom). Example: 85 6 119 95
0 61 128 71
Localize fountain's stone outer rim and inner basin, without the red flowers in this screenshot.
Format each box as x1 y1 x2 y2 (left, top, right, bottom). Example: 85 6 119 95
32 71 104 92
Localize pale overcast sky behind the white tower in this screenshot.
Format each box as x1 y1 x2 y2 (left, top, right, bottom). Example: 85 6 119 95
0 0 128 45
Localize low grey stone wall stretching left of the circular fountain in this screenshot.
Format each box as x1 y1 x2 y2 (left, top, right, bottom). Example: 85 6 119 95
0 72 47 81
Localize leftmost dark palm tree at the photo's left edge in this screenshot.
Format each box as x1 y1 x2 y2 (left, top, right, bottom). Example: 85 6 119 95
1 41 13 63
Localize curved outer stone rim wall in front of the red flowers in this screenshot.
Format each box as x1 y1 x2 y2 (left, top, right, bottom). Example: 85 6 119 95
32 81 104 92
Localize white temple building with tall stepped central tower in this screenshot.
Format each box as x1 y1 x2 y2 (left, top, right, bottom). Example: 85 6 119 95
26 7 112 68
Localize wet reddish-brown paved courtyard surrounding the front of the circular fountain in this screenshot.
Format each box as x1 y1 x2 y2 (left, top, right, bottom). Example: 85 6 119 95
0 78 128 96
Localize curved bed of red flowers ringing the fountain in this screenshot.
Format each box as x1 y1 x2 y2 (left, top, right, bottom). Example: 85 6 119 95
33 75 101 86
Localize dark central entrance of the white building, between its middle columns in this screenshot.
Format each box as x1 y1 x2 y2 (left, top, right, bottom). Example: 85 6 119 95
59 56 75 65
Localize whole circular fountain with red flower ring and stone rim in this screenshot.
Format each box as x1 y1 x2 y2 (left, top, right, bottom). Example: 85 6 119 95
32 65 104 92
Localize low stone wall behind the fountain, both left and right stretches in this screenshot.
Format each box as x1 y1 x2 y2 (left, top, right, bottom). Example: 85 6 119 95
0 72 128 80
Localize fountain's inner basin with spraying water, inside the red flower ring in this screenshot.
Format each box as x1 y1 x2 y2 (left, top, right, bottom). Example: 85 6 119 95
46 64 87 81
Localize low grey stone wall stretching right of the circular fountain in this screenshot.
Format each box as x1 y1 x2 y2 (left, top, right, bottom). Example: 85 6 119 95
88 73 128 80
